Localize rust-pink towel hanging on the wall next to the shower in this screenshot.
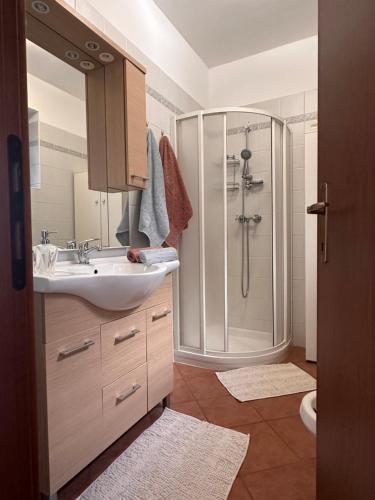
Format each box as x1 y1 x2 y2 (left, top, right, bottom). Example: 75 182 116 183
159 136 193 248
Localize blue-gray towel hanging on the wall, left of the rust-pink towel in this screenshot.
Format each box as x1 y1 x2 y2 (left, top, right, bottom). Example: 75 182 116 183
139 129 169 247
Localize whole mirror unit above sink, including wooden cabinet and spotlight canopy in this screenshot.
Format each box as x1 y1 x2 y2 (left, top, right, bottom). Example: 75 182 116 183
26 0 148 248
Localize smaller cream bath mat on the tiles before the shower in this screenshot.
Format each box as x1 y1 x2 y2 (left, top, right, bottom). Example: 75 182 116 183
216 363 316 402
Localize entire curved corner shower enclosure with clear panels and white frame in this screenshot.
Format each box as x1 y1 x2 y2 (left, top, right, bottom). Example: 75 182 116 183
174 108 291 369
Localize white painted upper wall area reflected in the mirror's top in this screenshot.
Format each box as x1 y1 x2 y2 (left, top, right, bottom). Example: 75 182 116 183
27 73 86 137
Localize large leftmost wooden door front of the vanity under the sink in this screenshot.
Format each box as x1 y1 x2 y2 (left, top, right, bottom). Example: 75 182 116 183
45 328 102 491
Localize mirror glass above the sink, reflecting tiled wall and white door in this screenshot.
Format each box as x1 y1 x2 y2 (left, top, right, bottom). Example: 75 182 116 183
27 41 127 248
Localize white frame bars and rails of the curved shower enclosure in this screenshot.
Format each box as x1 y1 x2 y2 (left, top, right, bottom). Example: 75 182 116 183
171 107 292 363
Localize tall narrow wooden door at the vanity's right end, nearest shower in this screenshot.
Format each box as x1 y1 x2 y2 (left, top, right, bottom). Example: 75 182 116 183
147 301 173 410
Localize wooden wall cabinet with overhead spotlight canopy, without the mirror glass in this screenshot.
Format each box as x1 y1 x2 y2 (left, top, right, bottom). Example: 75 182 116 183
26 0 147 191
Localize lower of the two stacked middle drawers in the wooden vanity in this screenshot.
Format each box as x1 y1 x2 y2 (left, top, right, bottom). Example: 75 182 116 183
103 364 147 445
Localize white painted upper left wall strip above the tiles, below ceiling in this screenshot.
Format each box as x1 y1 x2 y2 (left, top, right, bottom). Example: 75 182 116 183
82 0 208 106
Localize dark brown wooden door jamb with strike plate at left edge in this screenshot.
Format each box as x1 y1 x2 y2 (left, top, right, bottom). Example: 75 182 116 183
0 0 38 500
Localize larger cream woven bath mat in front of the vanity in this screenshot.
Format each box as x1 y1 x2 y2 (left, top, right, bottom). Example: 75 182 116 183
79 409 249 500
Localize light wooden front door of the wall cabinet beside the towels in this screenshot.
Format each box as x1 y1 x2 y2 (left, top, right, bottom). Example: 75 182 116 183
124 60 148 189
